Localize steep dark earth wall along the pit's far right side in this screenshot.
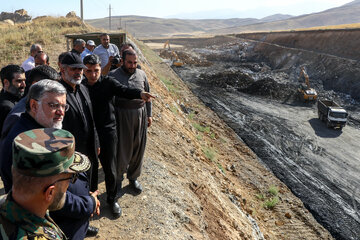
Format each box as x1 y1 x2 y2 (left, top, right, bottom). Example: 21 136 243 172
236 29 360 99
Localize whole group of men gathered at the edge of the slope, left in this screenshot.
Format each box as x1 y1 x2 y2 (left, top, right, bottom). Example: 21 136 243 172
0 34 154 239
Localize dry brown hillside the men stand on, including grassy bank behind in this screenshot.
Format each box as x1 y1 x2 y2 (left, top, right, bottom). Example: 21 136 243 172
1 18 332 239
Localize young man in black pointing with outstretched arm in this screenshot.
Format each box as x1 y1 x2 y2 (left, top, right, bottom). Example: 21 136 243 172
84 54 153 216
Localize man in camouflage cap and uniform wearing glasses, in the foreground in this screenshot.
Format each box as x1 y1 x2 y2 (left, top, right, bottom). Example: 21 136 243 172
0 128 90 240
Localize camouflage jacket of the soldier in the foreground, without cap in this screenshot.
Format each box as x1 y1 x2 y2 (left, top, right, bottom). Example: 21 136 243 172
0 192 67 240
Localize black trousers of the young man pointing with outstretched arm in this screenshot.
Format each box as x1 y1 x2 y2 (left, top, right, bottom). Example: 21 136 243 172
99 130 118 203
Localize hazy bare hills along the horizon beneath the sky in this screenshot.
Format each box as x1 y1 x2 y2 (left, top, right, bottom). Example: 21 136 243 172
85 0 360 38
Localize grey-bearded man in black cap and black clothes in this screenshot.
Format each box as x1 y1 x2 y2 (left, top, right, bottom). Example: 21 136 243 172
60 52 100 192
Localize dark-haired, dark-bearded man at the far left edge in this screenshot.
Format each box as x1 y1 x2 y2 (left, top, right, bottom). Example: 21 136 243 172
0 65 26 132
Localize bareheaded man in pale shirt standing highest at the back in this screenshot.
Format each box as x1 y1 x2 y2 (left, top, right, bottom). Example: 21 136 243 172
94 33 120 75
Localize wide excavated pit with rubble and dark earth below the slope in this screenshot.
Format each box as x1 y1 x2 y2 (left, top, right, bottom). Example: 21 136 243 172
147 31 360 240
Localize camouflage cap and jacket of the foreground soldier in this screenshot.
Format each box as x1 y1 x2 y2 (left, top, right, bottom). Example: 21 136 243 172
0 128 90 240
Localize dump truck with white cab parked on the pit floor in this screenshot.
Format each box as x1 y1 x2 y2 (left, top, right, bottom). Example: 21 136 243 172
317 99 348 130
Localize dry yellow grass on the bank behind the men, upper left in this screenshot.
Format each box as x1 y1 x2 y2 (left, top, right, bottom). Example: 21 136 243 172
0 17 92 67
